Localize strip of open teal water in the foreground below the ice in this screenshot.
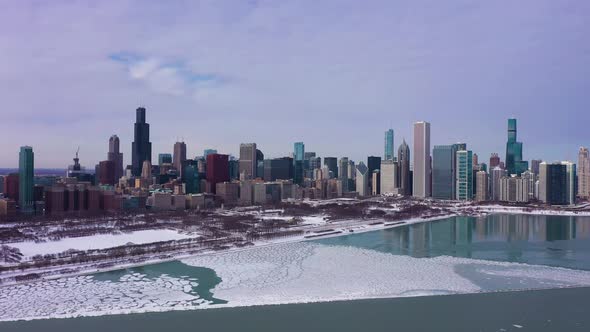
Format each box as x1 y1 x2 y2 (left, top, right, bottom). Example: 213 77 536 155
0 288 590 332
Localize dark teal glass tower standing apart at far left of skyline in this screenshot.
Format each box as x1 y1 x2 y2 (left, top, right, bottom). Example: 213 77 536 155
18 146 35 213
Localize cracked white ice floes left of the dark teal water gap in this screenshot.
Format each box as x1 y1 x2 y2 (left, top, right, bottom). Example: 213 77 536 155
0 273 207 321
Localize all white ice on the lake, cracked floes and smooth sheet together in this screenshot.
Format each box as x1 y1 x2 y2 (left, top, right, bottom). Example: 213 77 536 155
0 242 590 321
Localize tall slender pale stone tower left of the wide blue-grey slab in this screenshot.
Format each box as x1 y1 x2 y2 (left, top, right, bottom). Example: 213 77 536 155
412 121 431 198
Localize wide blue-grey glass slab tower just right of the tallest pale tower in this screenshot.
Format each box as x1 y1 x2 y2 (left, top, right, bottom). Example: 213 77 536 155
432 145 457 200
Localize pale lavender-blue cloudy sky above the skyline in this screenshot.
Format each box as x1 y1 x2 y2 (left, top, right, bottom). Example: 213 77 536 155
0 0 590 168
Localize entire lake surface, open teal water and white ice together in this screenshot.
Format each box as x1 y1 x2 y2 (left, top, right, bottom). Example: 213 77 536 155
0 215 590 331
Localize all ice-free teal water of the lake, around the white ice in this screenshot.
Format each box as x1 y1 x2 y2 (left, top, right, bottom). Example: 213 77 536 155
0 215 590 332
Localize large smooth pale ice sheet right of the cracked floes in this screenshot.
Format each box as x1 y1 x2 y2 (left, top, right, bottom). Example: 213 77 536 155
183 242 590 306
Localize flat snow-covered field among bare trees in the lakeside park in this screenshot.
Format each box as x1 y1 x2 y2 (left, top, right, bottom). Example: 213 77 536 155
6 229 191 257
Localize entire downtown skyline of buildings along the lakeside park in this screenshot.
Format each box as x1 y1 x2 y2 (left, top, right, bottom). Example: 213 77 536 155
0 107 590 216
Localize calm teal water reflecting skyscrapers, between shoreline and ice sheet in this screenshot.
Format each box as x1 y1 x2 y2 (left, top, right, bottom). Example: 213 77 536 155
315 215 590 270
